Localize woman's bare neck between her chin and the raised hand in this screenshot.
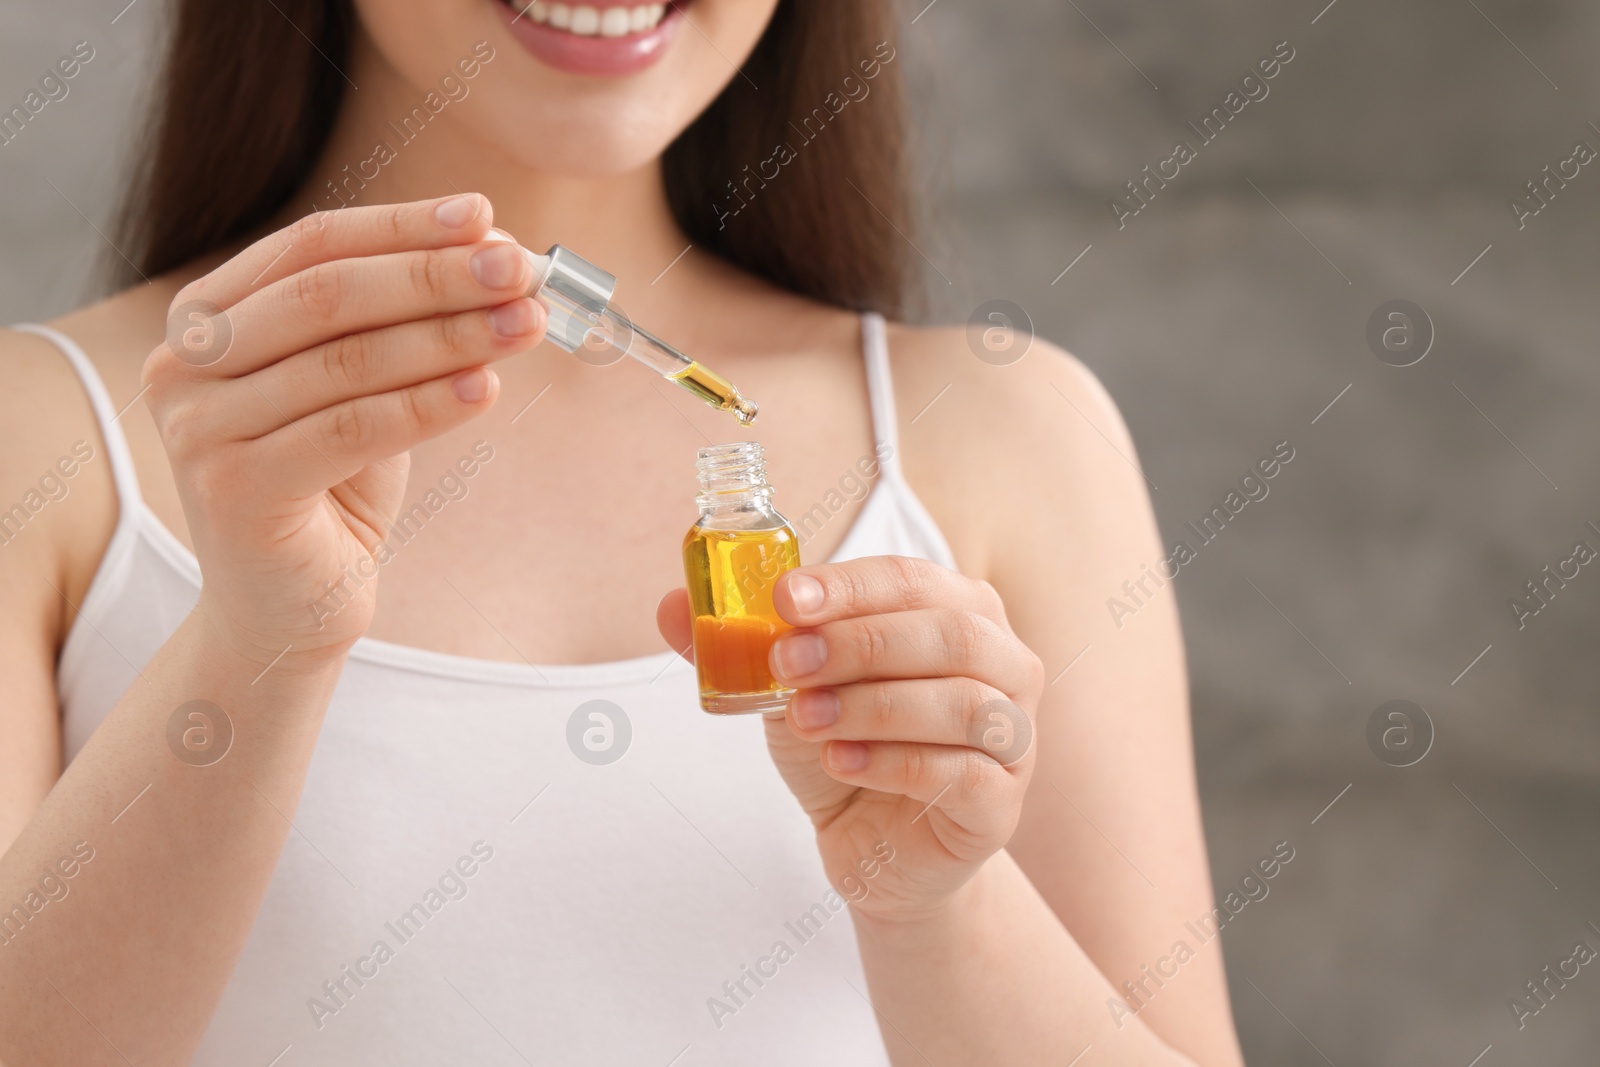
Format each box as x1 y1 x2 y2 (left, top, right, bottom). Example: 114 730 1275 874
282 25 688 300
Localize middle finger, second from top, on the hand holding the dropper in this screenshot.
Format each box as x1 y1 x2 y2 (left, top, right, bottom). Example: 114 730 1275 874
188 240 534 378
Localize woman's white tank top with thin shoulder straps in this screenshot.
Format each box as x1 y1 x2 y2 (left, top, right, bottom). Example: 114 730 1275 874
19 315 954 1067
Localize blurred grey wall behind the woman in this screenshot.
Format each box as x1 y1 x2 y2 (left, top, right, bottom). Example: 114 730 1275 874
0 0 1600 1067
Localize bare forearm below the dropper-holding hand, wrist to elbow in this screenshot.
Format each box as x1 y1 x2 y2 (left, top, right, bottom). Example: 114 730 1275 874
0 616 341 1064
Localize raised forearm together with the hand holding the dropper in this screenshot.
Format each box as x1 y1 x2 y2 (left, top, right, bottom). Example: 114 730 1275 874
0 197 544 1065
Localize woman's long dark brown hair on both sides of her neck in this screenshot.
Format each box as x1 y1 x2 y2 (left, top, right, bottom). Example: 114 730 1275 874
114 0 915 317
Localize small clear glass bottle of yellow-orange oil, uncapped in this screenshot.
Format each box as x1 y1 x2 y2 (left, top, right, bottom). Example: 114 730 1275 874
683 442 800 715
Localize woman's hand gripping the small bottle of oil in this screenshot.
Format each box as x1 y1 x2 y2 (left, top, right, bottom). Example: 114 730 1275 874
658 557 1043 920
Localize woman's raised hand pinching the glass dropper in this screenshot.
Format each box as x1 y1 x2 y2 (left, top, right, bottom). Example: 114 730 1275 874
144 194 544 659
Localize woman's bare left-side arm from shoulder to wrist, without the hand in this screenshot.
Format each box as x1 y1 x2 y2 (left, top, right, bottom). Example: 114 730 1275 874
0 336 350 1064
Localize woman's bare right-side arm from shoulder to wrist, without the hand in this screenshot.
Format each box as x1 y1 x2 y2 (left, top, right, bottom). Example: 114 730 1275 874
796 334 1243 1067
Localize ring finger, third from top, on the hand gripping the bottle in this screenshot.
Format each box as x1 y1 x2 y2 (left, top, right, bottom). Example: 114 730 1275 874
787 678 1034 766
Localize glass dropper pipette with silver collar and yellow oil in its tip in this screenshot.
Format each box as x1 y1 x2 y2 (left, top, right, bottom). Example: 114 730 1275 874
528 245 755 426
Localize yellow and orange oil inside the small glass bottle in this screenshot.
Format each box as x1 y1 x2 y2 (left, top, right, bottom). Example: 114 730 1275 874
683 523 800 713
